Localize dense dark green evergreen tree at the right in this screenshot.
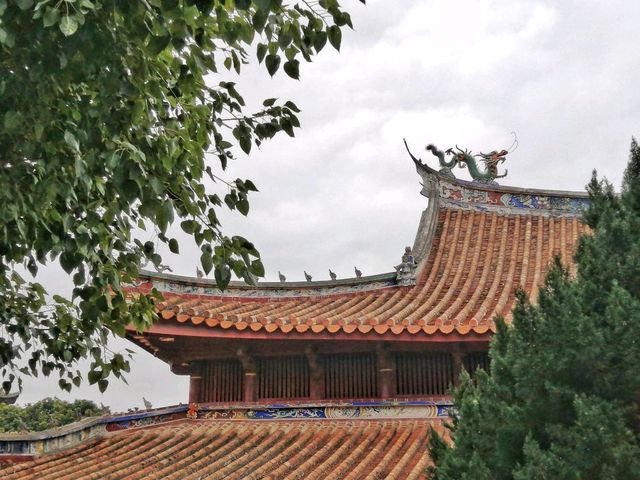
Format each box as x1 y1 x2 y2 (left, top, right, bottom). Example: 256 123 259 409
430 140 640 480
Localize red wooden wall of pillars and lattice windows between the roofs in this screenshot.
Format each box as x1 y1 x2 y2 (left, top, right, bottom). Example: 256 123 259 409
194 352 489 403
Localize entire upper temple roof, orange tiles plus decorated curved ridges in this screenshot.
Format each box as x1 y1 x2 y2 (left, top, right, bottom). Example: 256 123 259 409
127 159 588 349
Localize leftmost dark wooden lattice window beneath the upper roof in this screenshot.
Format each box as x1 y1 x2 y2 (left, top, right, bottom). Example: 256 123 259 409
200 359 244 402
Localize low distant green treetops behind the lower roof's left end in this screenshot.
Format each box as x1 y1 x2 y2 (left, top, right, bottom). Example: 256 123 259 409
0 397 110 432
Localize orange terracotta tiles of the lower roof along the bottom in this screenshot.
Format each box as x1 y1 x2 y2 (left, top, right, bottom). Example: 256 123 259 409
0 419 443 480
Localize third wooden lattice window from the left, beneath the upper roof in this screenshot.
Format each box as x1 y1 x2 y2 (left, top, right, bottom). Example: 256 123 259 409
323 353 378 398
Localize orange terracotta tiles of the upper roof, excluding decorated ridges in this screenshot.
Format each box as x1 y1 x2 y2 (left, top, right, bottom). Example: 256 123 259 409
134 208 585 335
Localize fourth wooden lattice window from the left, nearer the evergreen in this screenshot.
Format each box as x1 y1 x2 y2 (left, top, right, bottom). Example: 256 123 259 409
395 352 454 395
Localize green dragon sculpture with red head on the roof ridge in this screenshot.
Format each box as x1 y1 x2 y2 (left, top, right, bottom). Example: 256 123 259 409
405 140 517 183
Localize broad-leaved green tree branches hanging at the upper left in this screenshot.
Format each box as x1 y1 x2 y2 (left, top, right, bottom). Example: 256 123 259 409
0 0 360 390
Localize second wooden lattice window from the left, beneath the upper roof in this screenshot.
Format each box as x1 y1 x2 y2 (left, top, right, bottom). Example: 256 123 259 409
257 355 309 398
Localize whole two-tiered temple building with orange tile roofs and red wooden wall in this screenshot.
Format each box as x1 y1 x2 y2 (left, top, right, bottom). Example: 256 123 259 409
0 147 588 479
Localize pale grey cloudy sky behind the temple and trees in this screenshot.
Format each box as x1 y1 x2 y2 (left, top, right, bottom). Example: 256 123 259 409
21 0 640 411
